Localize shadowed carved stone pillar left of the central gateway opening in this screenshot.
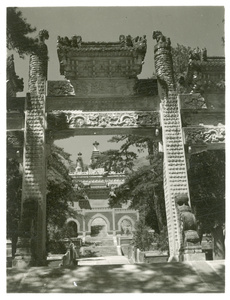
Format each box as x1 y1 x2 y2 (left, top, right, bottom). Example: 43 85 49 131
13 30 48 267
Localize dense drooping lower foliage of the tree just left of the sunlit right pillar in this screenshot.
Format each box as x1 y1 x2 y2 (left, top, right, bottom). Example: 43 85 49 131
109 156 166 233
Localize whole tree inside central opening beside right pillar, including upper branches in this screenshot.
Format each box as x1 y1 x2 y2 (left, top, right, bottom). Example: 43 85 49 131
91 135 166 249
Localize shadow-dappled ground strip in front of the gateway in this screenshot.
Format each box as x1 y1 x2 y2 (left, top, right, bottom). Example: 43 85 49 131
7 262 225 293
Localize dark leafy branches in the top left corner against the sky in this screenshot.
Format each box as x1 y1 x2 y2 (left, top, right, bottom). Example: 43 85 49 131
6 7 36 58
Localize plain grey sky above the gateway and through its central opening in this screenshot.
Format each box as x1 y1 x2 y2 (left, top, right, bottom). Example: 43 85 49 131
4 1 224 163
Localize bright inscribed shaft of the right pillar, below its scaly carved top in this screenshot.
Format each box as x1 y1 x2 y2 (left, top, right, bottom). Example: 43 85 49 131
161 92 189 260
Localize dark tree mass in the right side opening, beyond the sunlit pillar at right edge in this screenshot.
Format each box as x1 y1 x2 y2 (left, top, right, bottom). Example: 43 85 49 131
188 150 225 259
